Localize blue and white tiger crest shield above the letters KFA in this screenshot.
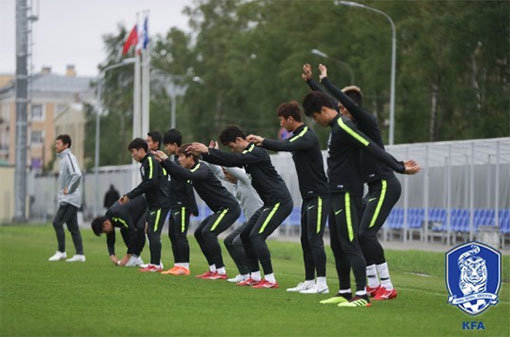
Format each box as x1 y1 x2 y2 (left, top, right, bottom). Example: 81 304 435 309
446 242 501 315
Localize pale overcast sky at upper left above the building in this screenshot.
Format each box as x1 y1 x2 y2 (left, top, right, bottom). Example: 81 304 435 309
0 0 193 76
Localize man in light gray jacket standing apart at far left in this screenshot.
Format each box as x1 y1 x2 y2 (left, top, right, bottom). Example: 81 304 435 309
49 135 85 262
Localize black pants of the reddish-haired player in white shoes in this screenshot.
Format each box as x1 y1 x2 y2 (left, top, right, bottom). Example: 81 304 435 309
301 196 329 280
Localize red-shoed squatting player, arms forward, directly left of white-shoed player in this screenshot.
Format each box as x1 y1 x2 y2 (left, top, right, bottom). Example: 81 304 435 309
187 125 293 288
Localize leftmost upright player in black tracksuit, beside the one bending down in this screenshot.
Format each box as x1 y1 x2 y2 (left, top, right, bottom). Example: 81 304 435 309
119 138 170 272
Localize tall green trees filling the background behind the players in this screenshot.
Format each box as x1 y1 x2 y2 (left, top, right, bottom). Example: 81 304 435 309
84 0 510 165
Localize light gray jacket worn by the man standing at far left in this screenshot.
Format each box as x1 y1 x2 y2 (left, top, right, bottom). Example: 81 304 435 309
57 149 81 208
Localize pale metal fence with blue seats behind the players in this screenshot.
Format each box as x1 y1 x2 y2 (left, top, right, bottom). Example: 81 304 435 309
28 137 510 246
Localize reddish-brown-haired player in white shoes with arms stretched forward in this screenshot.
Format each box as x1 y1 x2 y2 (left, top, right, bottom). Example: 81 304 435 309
248 101 329 294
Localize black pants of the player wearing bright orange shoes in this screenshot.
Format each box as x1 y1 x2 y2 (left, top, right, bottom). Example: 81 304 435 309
168 207 190 263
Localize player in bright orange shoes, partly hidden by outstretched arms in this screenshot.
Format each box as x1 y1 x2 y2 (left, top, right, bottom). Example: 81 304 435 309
161 129 198 275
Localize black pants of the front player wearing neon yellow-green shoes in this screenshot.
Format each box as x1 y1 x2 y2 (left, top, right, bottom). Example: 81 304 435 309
329 192 366 291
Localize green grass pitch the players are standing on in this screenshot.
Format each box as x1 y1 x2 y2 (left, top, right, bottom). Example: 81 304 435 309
0 225 510 336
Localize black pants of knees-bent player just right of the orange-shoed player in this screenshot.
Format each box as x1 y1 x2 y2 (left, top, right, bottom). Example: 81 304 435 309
195 204 241 268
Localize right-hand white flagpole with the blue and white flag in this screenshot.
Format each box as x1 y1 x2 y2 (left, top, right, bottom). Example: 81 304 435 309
141 10 150 137
